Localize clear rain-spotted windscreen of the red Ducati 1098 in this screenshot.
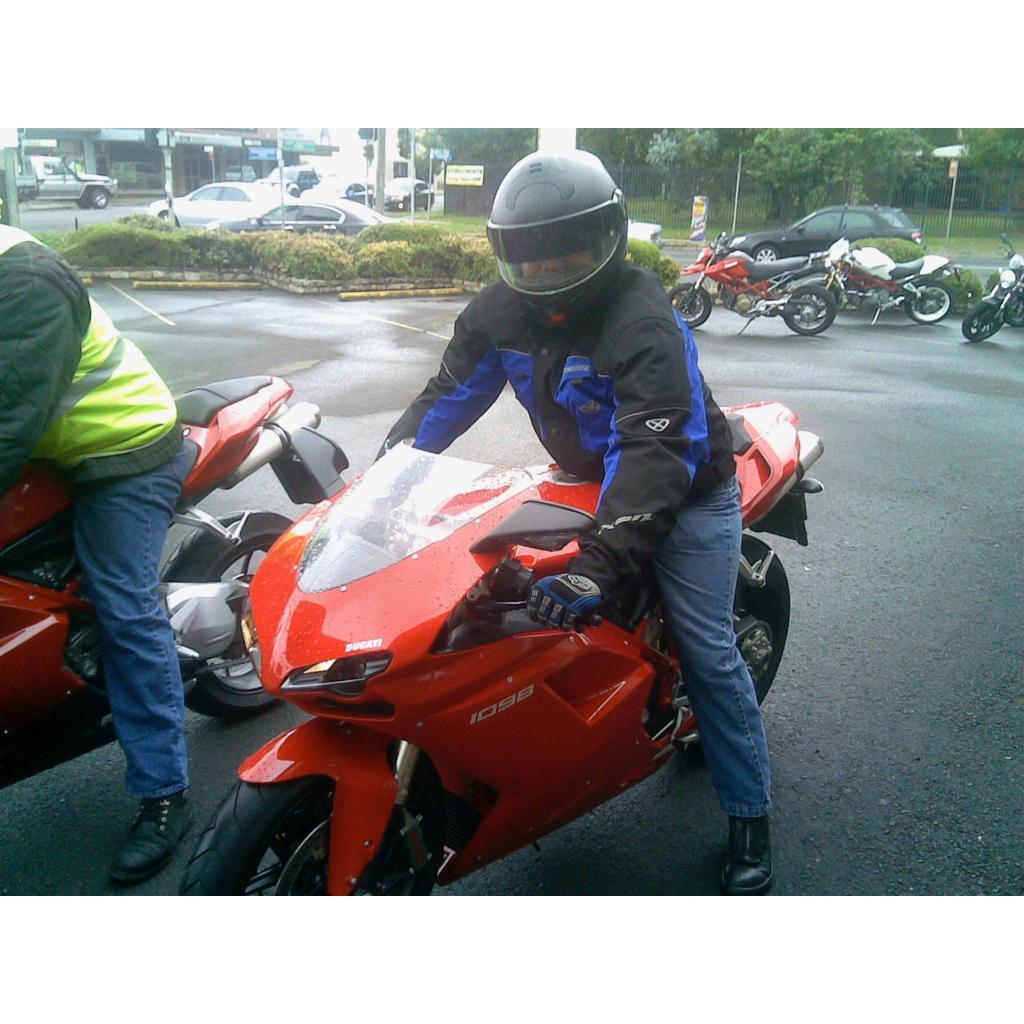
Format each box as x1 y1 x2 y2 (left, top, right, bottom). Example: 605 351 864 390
299 444 532 594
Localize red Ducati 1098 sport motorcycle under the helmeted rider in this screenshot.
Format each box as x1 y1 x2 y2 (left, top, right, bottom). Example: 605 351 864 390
181 402 822 896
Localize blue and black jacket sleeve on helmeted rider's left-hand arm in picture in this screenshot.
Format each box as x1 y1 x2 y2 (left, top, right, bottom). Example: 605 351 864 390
380 294 507 455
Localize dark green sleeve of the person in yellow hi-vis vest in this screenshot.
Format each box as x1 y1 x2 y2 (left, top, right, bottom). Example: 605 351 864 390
0 249 89 494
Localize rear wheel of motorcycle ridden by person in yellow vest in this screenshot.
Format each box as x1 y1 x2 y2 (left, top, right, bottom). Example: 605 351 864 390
163 512 291 721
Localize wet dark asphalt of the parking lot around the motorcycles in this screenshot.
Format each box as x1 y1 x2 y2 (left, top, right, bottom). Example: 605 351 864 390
0 284 1024 895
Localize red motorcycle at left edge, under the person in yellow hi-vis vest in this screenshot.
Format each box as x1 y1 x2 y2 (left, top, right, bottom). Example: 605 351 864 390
0 377 347 786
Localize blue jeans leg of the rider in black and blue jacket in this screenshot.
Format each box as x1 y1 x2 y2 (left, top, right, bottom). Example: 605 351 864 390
653 477 771 818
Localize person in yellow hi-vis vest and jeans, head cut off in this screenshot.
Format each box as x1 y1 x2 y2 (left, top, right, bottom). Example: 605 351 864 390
0 225 191 884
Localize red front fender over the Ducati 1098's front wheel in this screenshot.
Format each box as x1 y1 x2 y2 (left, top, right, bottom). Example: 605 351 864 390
239 718 398 896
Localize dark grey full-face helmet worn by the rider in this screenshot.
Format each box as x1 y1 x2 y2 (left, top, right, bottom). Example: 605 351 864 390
487 150 628 323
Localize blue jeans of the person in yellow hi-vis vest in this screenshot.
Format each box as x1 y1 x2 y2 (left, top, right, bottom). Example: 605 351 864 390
74 447 190 797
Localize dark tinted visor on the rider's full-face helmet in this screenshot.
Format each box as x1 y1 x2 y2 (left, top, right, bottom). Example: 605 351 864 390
487 200 626 295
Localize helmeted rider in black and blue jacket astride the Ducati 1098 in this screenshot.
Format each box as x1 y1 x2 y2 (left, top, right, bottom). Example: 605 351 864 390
382 151 772 895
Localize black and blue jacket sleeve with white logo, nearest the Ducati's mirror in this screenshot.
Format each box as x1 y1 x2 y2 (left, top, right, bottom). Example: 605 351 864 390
571 316 709 594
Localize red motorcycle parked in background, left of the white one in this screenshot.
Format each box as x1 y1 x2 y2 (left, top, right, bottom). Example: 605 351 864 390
669 234 838 335
